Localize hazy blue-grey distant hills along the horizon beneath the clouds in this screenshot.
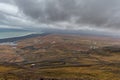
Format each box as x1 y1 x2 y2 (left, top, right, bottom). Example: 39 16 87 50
42 28 116 37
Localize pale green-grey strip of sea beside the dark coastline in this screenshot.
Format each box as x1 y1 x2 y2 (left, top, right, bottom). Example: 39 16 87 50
0 31 35 39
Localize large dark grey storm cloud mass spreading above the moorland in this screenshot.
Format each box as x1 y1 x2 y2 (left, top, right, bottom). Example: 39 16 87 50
10 0 120 29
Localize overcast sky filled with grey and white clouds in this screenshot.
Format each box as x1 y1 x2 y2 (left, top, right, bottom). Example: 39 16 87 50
0 0 120 32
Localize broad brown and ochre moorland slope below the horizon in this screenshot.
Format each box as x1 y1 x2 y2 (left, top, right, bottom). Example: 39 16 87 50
0 34 120 80
